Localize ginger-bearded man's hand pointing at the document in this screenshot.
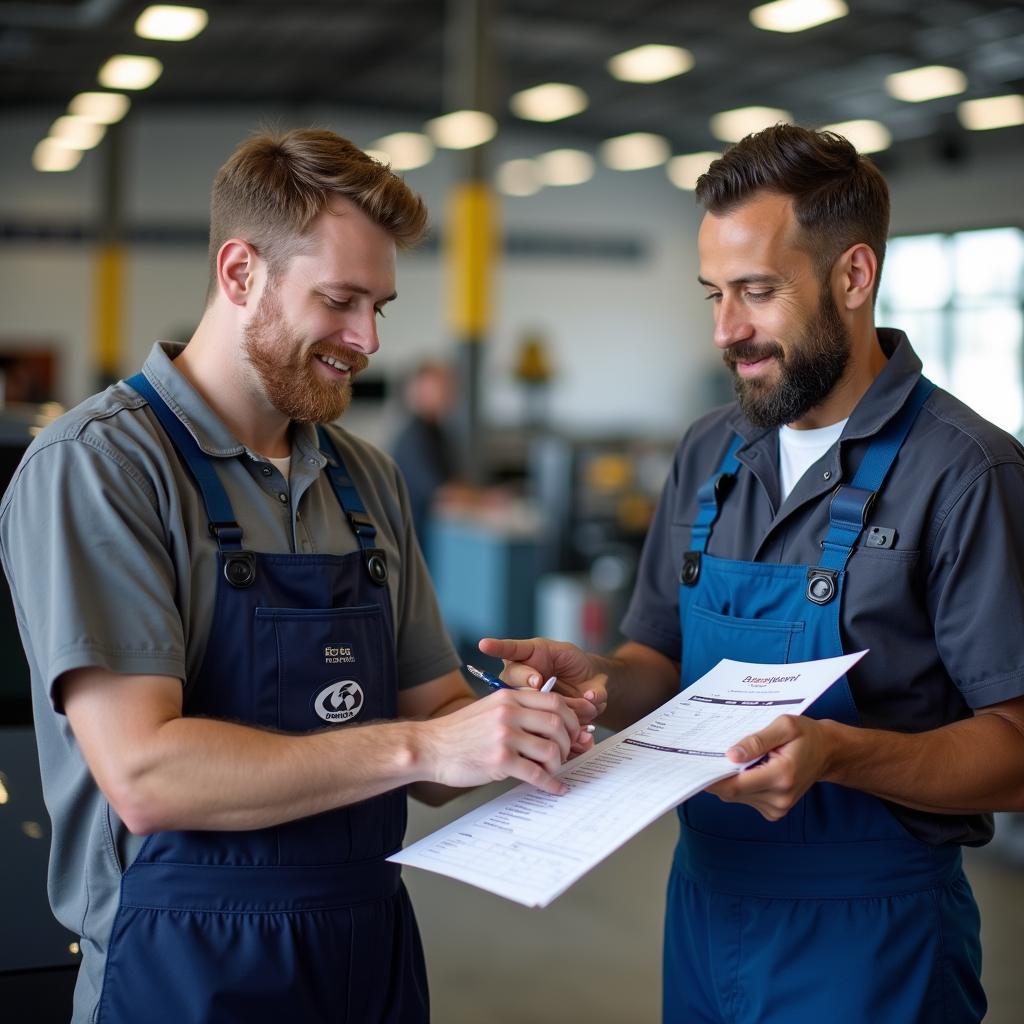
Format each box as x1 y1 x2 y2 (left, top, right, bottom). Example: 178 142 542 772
418 688 593 795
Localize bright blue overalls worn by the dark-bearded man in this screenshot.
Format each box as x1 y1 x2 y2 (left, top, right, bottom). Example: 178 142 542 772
664 380 985 1024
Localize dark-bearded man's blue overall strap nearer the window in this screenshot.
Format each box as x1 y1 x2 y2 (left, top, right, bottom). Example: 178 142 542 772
807 377 935 604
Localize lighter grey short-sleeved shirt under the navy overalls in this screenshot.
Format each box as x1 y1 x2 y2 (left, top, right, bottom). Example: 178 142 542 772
0 343 459 1020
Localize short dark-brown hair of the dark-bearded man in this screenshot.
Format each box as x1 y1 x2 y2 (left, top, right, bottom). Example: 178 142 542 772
696 124 889 293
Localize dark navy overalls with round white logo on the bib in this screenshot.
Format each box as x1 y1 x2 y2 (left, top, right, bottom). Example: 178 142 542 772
96 375 429 1024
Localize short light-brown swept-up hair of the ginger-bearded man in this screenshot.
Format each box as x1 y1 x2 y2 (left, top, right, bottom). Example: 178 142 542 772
208 128 427 298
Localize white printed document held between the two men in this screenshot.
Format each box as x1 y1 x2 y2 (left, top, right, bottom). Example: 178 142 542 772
388 651 866 906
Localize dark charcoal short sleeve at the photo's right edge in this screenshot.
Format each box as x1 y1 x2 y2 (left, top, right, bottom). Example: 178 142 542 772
928 461 1024 708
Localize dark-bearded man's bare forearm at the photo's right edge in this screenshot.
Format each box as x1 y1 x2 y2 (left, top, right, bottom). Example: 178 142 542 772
821 714 1024 814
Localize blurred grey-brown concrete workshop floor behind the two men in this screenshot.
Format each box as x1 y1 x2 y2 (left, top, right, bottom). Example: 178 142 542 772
404 787 1024 1024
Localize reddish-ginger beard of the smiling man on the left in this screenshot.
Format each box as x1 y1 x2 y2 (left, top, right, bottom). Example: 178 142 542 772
243 283 367 423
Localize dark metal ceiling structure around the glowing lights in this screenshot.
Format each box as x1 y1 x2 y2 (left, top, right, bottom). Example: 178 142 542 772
0 0 1024 163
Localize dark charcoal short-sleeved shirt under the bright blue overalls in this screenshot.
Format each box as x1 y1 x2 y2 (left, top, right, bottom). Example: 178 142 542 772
623 329 1024 845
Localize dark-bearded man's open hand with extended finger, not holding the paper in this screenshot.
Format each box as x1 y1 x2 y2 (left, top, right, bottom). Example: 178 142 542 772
479 637 608 726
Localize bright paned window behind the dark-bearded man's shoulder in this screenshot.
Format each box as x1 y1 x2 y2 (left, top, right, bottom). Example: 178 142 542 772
879 227 1024 437
